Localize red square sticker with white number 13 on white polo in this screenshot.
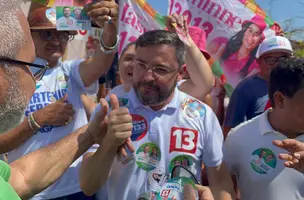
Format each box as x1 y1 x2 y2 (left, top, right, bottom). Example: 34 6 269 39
169 127 198 154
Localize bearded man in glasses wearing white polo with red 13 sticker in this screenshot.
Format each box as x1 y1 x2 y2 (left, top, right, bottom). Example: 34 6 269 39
80 30 234 200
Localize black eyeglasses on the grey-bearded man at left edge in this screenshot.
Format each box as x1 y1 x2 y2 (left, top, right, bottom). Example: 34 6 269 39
0 58 50 81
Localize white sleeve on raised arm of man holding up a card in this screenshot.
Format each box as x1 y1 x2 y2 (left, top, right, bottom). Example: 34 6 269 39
62 59 98 95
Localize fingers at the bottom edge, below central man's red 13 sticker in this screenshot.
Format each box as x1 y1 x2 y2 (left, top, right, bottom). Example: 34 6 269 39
184 184 214 200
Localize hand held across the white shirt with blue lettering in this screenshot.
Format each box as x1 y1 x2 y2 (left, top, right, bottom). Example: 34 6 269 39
33 94 75 127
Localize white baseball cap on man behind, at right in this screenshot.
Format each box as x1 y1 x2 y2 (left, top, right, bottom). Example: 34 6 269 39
255 36 293 58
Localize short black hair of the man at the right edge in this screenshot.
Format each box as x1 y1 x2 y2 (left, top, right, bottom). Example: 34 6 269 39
269 58 304 107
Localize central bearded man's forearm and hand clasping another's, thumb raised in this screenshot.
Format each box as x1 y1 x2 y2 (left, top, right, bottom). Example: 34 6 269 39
80 94 134 195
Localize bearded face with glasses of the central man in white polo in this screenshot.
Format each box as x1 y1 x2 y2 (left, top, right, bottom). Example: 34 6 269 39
133 44 179 110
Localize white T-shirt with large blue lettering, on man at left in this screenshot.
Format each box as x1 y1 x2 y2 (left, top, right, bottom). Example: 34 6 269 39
8 59 98 200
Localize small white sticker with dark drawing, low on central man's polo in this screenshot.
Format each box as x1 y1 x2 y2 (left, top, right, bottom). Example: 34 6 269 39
148 168 169 193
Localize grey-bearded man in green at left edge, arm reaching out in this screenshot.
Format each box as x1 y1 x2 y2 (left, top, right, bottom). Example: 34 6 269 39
0 0 131 200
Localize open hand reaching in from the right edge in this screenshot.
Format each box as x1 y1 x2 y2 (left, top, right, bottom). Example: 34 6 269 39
273 139 304 173
